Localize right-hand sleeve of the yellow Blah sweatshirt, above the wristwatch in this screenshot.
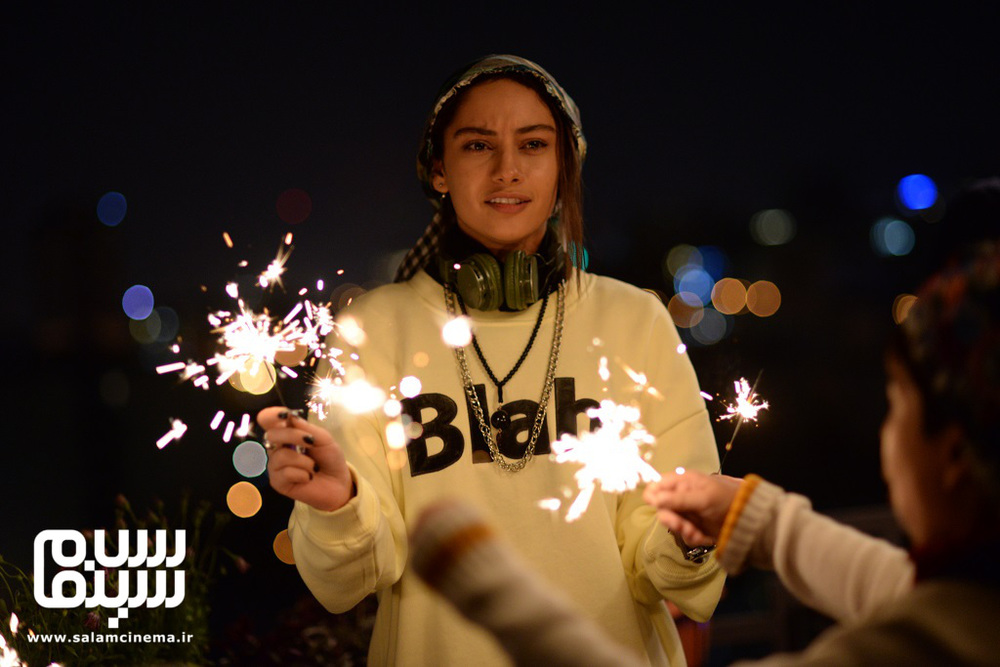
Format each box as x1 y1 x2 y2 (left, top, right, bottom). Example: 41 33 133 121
617 296 725 622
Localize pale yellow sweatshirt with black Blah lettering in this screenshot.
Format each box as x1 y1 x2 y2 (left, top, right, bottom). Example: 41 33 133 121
289 272 724 667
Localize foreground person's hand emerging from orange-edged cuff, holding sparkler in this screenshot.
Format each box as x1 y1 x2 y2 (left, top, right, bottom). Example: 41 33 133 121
642 470 742 546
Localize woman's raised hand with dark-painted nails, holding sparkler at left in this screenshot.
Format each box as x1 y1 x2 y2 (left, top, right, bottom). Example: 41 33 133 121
257 407 354 511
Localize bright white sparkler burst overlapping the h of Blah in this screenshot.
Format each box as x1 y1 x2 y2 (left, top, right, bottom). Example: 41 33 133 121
550 400 660 522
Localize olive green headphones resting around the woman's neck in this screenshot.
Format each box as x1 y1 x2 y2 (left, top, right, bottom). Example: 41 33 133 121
441 250 540 310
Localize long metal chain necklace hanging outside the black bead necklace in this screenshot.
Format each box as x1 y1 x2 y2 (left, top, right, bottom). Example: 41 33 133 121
444 281 566 472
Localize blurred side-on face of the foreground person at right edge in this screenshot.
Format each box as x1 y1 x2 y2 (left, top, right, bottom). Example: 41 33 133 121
881 356 951 547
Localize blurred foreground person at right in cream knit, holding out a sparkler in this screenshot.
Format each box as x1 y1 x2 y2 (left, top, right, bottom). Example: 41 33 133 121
646 242 1000 665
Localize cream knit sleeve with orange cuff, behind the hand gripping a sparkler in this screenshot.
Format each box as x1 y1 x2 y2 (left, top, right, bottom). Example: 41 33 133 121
717 476 914 621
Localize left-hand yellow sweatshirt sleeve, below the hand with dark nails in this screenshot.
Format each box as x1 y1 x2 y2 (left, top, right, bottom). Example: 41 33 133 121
288 310 407 613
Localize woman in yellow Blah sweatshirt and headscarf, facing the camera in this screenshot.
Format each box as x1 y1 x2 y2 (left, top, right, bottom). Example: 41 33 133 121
258 56 723 665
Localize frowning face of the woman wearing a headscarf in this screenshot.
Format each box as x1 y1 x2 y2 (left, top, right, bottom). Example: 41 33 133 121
432 79 559 257
